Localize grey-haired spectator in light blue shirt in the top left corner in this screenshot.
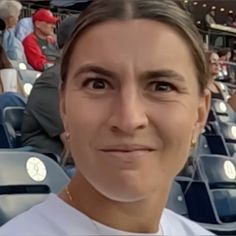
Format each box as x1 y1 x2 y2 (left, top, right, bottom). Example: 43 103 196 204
0 0 25 61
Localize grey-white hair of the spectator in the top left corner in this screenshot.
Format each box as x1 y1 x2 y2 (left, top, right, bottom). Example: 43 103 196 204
0 0 22 19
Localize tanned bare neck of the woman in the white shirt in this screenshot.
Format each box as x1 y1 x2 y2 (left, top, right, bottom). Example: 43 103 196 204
60 172 170 233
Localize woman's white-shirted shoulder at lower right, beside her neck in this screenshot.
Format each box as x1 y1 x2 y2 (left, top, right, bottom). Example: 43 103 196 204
161 209 214 235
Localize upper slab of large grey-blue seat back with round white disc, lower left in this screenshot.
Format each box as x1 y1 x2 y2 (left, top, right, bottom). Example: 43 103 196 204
0 151 69 193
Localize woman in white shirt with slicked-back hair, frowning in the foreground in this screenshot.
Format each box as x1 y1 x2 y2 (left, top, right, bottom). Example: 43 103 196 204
0 0 214 236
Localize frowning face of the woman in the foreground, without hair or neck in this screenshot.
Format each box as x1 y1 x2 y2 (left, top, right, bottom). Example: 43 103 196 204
61 20 208 202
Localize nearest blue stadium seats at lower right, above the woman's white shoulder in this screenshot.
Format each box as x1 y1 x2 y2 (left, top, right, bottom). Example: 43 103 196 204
170 154 236 235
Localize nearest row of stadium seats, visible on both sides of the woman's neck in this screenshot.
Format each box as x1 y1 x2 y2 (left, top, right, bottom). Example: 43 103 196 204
0 150 236 235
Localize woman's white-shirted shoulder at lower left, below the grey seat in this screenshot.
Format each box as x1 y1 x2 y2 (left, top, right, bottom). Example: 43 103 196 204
0 194 95 236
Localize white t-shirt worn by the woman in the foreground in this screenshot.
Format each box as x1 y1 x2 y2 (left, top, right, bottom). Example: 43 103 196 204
0 194 213 236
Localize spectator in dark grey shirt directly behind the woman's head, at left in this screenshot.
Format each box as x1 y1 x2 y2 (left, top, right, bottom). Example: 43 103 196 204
22 16 77 156
